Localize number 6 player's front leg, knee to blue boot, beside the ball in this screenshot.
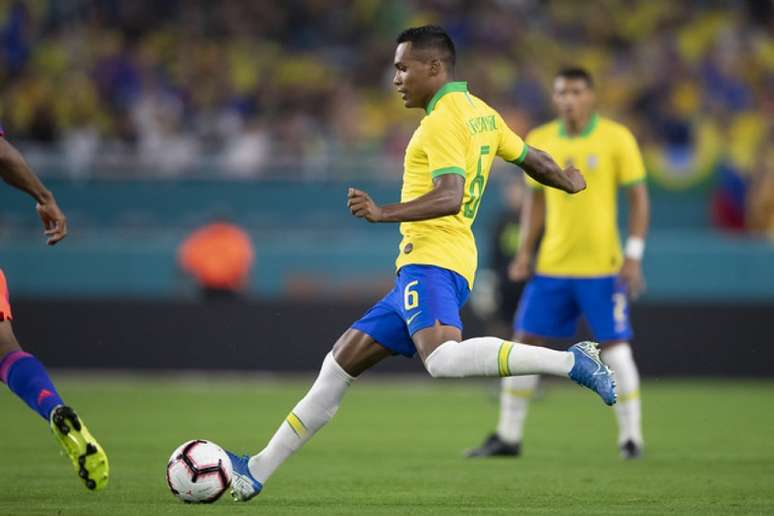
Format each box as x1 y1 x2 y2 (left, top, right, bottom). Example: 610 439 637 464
229 328 392 501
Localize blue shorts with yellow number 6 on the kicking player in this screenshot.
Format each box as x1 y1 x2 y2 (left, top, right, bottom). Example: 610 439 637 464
352 265 470 357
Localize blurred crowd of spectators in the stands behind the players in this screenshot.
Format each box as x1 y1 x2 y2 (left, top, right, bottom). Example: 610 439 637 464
0 0 774 234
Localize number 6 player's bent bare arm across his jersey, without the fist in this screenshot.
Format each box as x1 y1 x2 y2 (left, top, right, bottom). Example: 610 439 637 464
378 174 465 222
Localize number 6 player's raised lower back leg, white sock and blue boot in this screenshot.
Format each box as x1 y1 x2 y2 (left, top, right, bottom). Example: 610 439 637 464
422 329 616 405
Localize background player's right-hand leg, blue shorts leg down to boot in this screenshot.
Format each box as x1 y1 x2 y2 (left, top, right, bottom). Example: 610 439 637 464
578 277 644 459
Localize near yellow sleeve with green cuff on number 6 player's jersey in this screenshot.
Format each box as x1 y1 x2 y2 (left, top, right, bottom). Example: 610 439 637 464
423 113 468 179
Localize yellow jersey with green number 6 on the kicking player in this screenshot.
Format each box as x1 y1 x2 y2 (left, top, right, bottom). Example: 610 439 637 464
395 82 527 288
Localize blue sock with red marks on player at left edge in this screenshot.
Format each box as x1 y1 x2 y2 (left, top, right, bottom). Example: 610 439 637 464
0 351 64 421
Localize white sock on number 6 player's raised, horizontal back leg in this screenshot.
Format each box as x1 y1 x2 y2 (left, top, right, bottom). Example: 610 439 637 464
425 337 575 378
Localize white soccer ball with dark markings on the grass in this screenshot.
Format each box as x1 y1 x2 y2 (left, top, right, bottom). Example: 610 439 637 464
167 439 231 503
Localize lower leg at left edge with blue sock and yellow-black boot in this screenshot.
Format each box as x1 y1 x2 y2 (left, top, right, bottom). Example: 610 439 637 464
0 321 109 490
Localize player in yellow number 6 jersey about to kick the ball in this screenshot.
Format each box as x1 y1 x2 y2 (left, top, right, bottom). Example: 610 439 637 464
224 26 615 501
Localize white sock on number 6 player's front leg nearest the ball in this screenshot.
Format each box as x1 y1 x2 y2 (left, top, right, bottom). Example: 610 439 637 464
248 353 354 484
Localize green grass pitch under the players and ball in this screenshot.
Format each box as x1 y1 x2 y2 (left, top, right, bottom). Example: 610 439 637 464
0 375 774 516
